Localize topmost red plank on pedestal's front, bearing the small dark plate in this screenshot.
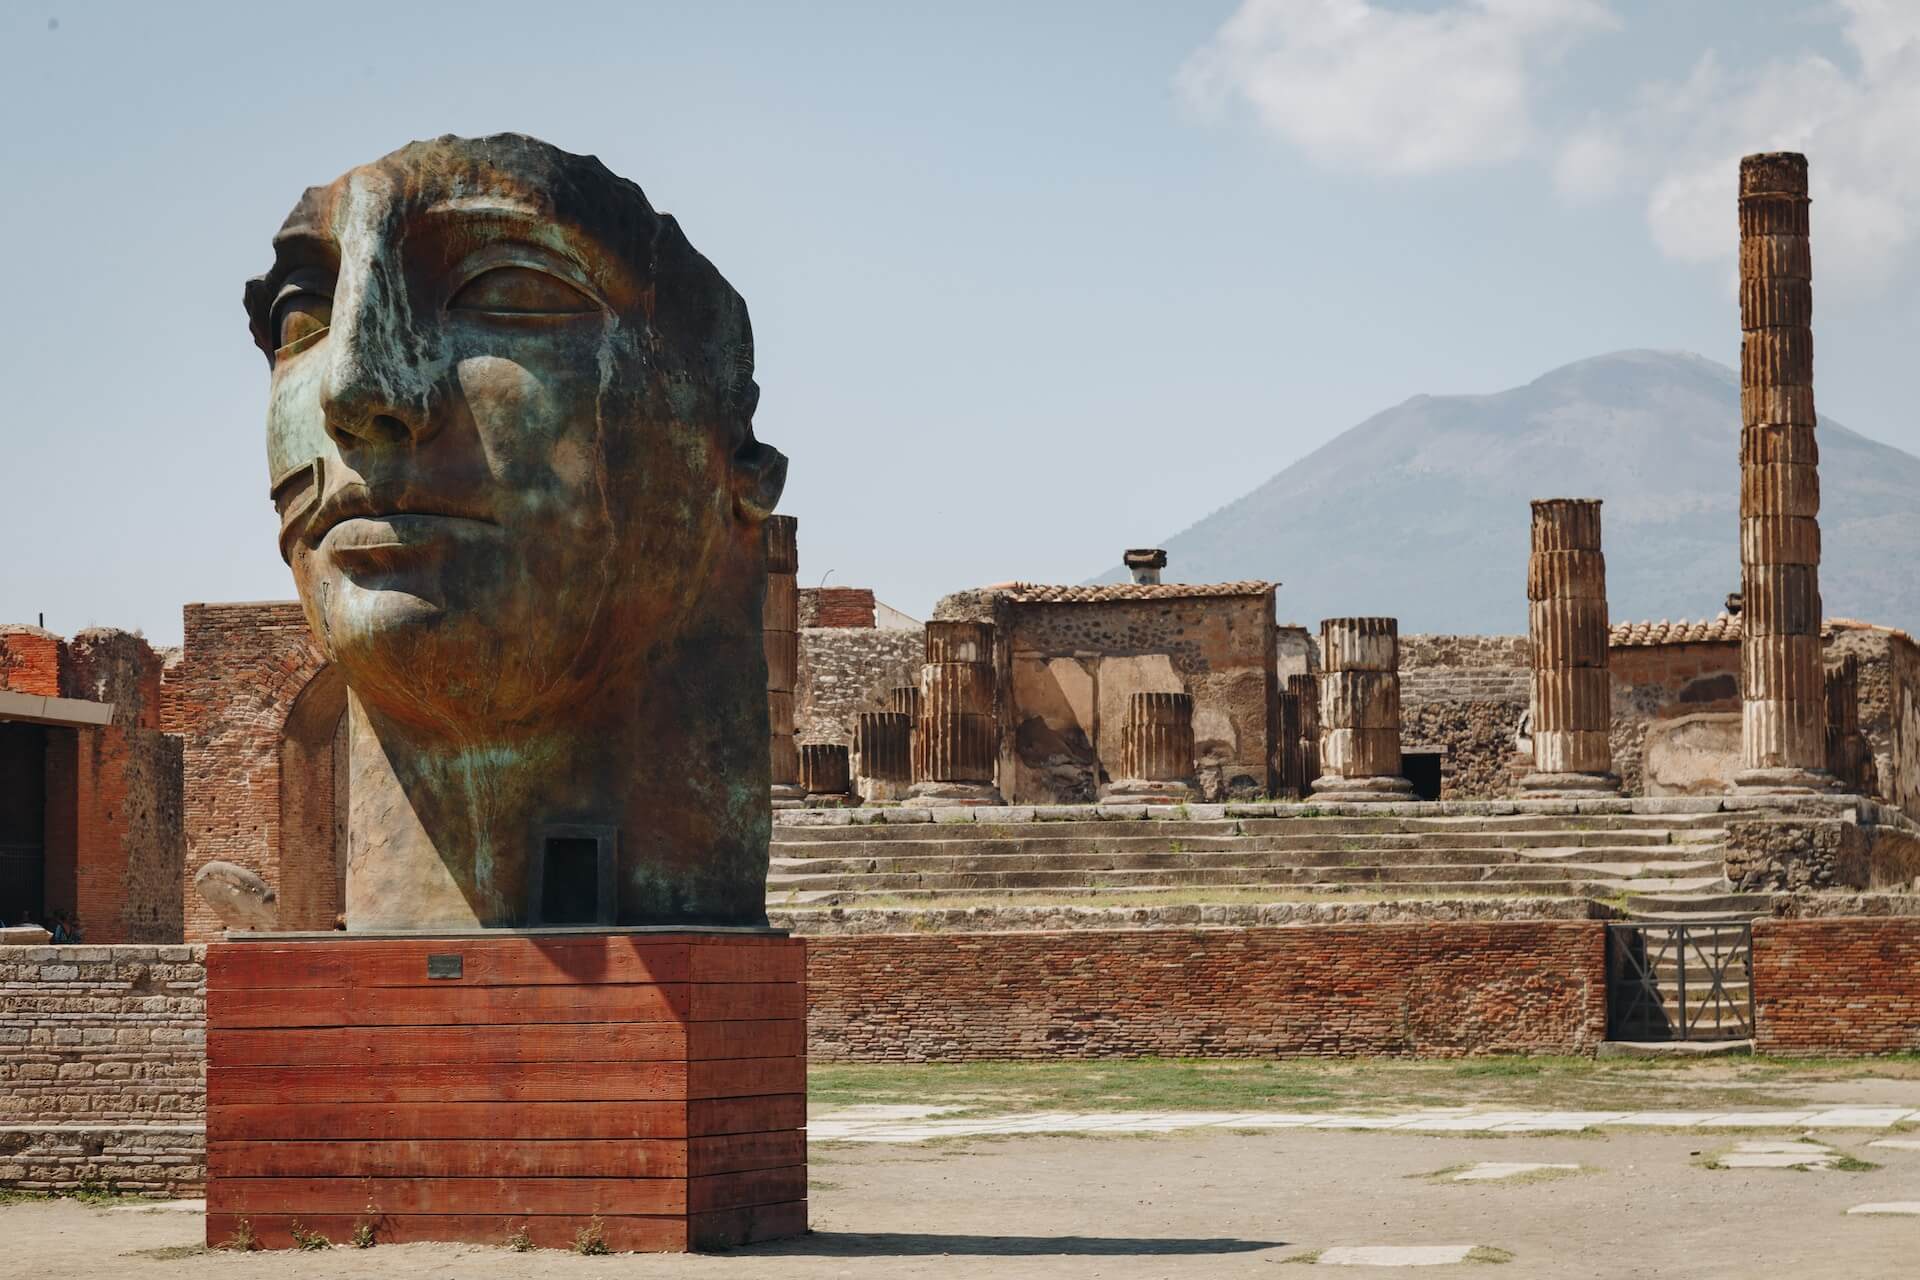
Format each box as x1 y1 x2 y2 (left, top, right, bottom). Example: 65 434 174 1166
207 935 698 990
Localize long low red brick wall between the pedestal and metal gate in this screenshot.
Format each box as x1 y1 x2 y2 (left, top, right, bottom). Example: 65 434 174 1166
806 921 1607 1061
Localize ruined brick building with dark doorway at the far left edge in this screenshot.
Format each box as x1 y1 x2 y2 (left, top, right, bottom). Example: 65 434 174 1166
0 626 182 942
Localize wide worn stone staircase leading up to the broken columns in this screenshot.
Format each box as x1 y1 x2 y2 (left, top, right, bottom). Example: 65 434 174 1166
768 800 1770 919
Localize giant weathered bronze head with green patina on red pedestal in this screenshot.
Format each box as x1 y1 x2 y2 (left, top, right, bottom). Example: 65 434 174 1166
246 134 785 929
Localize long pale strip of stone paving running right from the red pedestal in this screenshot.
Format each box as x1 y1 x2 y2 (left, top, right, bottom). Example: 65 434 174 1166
808 1107 1920 1155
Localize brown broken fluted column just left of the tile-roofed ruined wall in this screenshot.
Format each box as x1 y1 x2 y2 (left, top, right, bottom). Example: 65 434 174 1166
908 622 1002 806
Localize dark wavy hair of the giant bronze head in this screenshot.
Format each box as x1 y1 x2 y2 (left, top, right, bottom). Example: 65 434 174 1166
246 132 760 451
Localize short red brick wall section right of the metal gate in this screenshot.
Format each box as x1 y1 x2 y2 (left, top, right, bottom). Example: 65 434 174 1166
1753 917 1920 1055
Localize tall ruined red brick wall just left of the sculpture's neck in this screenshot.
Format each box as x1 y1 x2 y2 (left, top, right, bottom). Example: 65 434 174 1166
165 603 332 940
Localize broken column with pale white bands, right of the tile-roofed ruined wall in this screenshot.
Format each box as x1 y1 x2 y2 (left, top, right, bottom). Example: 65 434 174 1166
1313 618 1415 804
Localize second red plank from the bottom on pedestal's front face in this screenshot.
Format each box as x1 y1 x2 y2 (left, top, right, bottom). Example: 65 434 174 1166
207 1173 687 1217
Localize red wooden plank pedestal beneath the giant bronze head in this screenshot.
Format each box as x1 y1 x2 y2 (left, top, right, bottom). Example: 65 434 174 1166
207 931 806 1251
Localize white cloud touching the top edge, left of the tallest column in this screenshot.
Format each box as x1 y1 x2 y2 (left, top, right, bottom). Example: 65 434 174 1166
1177 0 1613 173
